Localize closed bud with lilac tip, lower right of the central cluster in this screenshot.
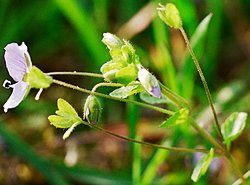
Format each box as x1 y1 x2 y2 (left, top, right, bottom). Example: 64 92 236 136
138 65 161 98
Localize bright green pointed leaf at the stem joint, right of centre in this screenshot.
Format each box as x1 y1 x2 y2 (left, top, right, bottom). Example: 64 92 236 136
160 108 189 128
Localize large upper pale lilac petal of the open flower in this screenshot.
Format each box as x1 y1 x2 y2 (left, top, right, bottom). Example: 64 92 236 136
4 43 31 81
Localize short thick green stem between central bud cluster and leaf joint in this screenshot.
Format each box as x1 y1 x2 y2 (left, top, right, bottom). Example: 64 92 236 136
159 82 190 109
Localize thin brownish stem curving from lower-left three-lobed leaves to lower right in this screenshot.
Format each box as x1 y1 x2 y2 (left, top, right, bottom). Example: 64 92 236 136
88 123 209 153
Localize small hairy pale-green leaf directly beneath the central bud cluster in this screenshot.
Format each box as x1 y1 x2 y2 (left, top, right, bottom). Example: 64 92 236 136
109 84 144 99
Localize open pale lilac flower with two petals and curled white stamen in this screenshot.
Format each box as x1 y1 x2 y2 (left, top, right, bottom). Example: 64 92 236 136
3 42 32 112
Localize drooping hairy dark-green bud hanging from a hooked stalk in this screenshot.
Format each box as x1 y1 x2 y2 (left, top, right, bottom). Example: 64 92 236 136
83 95 101 124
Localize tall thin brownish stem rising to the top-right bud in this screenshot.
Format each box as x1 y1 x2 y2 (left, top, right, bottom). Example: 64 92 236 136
180 27 223 138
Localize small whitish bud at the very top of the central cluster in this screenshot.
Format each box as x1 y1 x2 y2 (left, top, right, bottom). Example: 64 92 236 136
102 33 123 50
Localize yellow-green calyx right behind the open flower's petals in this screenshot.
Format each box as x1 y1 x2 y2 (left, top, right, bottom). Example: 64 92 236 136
23 66 53 89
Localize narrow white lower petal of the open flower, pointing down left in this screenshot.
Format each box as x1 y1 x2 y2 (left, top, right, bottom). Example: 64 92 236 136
3 81 28 112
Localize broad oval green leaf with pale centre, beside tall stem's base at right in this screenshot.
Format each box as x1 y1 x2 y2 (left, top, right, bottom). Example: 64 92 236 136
221 112 247 144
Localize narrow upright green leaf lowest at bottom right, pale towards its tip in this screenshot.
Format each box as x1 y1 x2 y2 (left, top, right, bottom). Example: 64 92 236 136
191 148 214 182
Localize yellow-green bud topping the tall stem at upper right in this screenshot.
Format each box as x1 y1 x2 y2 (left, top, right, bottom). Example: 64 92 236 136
158 3 182 29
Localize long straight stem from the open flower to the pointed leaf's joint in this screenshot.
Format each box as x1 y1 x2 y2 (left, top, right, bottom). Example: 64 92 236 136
53 79 174 115
